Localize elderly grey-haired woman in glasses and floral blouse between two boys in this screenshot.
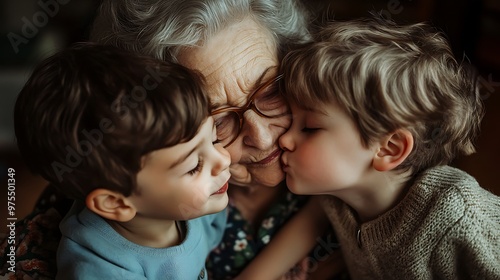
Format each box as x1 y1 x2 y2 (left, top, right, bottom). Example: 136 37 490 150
0 0 344 279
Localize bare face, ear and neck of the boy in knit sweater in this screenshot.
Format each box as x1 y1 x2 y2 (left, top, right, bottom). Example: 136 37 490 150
279 101 413 221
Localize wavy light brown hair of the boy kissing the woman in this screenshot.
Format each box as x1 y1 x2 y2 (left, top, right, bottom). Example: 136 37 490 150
281 18 483 172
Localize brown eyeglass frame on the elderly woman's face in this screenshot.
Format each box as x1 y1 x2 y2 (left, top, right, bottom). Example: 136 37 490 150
211 74 289 148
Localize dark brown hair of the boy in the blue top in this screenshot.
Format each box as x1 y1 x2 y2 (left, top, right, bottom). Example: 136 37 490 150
14 44 210 199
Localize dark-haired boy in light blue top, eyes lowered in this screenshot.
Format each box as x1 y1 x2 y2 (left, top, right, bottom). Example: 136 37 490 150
15 44 230 279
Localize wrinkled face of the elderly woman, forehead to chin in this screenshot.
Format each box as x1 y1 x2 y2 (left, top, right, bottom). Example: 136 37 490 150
179 19 290 187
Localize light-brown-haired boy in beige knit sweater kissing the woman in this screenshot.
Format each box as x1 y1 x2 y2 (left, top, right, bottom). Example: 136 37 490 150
236 19 500 279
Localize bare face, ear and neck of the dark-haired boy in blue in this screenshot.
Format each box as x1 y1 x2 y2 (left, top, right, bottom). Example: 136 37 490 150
97 117 230 248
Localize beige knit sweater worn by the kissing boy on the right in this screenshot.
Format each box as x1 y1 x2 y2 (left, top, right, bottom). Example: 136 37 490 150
323 166 500 280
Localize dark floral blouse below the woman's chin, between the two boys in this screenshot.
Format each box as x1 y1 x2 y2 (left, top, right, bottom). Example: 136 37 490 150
206 187 307 280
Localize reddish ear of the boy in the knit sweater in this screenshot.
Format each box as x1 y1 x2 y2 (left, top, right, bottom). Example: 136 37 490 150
373 129 413 171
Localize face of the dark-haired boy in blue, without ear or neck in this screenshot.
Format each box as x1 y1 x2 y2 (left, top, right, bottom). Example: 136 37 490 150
131 117 230 220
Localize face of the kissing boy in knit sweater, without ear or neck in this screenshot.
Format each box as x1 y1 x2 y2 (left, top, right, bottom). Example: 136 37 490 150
280 103 375 197
